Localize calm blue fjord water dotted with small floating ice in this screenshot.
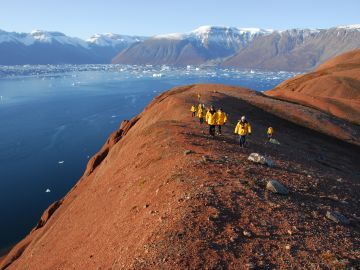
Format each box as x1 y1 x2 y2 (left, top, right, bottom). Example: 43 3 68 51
0 65 295 252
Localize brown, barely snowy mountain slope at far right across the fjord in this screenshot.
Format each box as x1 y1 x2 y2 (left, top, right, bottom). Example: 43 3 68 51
222 28 360 71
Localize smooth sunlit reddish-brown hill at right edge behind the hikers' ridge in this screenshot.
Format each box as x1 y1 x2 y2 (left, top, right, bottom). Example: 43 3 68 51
266 49 360 125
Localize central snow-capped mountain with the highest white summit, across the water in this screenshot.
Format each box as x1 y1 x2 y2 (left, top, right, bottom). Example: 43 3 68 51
113 26 272 65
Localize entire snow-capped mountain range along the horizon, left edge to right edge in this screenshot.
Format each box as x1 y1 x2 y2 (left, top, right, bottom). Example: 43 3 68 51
0 25 360 71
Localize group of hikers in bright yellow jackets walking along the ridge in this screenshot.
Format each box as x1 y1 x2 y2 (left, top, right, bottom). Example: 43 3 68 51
190 94 274 148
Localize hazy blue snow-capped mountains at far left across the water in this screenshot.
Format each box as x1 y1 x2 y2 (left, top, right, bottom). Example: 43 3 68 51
0 30 145 65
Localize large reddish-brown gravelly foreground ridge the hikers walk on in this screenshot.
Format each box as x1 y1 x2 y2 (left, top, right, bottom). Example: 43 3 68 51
0 85 360 270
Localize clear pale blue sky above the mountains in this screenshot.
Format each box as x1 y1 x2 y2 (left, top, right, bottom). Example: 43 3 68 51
0 0 360 38
